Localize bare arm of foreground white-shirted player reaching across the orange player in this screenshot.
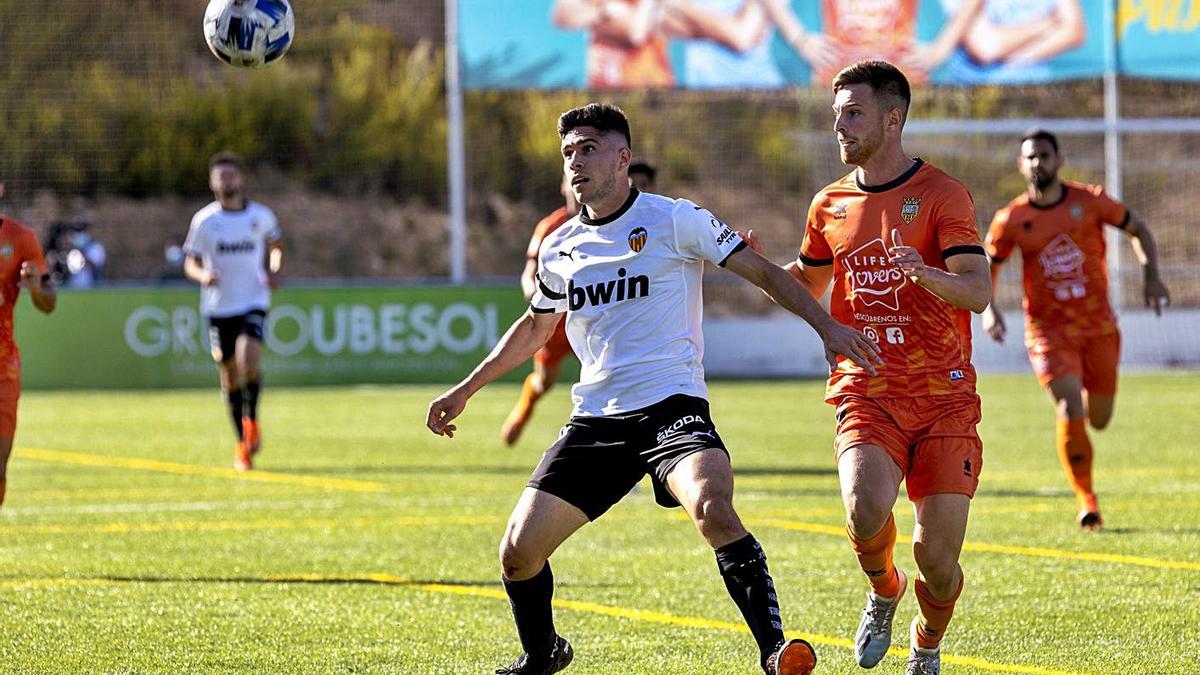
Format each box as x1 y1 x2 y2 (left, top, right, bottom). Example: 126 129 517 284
725 241 883 375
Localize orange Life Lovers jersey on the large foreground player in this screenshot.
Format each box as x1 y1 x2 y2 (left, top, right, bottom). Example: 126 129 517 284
799 160 984 401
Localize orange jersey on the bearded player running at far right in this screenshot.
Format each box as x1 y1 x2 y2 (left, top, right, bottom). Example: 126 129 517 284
988 181 1129 341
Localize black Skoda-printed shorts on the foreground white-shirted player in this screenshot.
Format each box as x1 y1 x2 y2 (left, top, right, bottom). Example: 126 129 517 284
528 394 728 520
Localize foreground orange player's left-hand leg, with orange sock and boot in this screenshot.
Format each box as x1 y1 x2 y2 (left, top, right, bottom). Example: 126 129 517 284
838 444 908 668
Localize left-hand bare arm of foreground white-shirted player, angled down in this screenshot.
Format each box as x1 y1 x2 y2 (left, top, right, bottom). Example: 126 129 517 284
425 310 562 438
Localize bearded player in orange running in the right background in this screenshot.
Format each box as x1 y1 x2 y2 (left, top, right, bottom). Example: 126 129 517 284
983 129 1170 530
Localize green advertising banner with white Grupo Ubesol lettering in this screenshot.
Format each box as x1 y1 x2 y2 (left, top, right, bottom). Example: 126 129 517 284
14 283 542 389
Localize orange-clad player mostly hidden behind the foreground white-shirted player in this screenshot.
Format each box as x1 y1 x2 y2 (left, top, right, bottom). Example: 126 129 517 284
500 161 658 446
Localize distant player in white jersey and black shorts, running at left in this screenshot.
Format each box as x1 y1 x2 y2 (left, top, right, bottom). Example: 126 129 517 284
184 153 283 471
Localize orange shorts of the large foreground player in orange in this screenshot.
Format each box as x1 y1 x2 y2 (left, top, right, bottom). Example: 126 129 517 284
833 394 983 501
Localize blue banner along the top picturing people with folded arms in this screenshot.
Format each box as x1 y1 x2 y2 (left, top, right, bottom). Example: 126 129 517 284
460 0 1200 89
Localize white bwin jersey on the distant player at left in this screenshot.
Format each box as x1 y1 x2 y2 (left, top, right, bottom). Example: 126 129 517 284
184 202 280 318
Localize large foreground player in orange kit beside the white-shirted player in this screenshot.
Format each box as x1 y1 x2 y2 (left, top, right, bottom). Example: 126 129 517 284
748 60 991 675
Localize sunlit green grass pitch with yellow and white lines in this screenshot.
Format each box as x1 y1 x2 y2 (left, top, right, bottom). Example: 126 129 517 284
0 374 1200 674
